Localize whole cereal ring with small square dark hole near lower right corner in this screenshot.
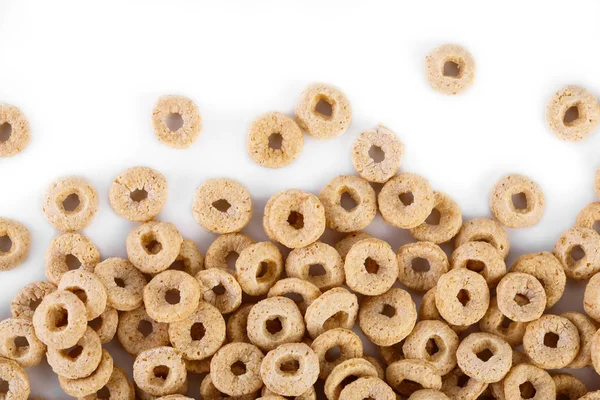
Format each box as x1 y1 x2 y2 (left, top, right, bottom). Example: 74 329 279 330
523 314 581 369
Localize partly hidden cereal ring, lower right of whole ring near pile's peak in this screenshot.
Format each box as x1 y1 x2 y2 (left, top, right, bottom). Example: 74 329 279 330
410 192 462 244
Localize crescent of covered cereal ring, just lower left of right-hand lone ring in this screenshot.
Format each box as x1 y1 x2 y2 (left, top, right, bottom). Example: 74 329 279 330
454 218 510 258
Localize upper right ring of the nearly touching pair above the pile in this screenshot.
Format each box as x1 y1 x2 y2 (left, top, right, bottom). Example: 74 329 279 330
294 83 352 140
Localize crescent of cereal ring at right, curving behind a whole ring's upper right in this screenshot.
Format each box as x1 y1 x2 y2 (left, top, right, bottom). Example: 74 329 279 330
510 251 567 309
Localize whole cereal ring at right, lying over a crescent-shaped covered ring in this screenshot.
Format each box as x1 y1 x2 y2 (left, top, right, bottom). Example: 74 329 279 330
496 272 546 322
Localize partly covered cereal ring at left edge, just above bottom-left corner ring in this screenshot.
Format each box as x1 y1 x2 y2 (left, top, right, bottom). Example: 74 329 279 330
0 318 46 368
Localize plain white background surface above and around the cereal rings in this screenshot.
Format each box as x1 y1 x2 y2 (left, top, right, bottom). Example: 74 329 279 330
0 0 600 398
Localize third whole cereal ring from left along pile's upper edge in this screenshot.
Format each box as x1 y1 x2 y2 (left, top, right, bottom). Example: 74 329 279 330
192 178 252 233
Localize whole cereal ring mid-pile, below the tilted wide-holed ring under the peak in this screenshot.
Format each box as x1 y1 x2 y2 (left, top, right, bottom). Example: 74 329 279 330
344 238 398 296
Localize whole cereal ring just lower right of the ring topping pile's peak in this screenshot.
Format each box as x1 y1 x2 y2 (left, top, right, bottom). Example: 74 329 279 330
377 172 434 229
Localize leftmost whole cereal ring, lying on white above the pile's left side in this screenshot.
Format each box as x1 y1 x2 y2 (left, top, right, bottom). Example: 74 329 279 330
42 177 98 232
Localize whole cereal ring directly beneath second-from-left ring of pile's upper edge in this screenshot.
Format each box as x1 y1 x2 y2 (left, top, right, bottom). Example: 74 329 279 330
125 221 183 274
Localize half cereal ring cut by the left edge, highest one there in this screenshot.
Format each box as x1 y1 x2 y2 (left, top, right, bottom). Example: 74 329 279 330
0 104 31 158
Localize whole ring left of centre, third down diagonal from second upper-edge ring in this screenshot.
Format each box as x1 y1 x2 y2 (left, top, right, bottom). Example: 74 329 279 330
144 270 201 323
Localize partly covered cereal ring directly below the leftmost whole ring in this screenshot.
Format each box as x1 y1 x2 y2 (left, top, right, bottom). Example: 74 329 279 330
44 233 100 285
